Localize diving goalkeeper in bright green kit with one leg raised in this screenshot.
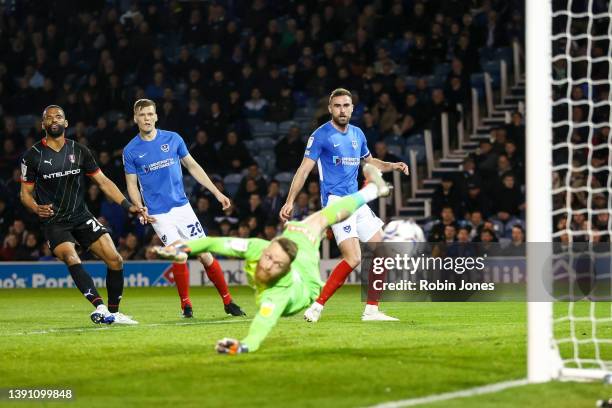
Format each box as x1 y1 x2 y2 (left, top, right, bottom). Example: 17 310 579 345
153 164 389 354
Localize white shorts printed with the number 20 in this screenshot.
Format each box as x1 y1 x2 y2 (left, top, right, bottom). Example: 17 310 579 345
151 203 206 245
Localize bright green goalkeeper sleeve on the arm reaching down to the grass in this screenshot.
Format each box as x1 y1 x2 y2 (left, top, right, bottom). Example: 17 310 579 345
241 288 290 352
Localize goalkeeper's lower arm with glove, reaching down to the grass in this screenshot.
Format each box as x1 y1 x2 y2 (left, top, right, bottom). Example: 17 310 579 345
216 288 289 354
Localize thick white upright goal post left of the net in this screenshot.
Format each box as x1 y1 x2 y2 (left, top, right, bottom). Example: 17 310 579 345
525 0 555 383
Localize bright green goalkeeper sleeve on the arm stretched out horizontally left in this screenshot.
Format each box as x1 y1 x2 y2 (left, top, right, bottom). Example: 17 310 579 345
187 237 270 261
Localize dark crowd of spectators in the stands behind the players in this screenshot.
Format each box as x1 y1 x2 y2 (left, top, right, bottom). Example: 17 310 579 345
0 0 525 260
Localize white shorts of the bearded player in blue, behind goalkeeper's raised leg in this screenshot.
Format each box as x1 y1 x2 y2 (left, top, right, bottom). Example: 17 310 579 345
327 195 384 244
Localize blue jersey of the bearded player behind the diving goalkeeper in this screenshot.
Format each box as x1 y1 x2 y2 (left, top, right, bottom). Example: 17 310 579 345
304 122 370 206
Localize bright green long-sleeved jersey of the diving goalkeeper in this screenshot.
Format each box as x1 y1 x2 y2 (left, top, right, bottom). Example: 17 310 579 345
187 222 323 351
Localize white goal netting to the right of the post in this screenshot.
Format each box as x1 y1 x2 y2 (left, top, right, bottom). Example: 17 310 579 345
552 0 612 371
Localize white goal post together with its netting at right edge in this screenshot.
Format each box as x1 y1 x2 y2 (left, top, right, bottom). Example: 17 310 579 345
526 0 612 382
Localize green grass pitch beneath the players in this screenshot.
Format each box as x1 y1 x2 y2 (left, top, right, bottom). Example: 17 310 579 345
0 287 612 408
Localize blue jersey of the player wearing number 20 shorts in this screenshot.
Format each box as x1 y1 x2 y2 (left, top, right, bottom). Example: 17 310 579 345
123 129 189 215
